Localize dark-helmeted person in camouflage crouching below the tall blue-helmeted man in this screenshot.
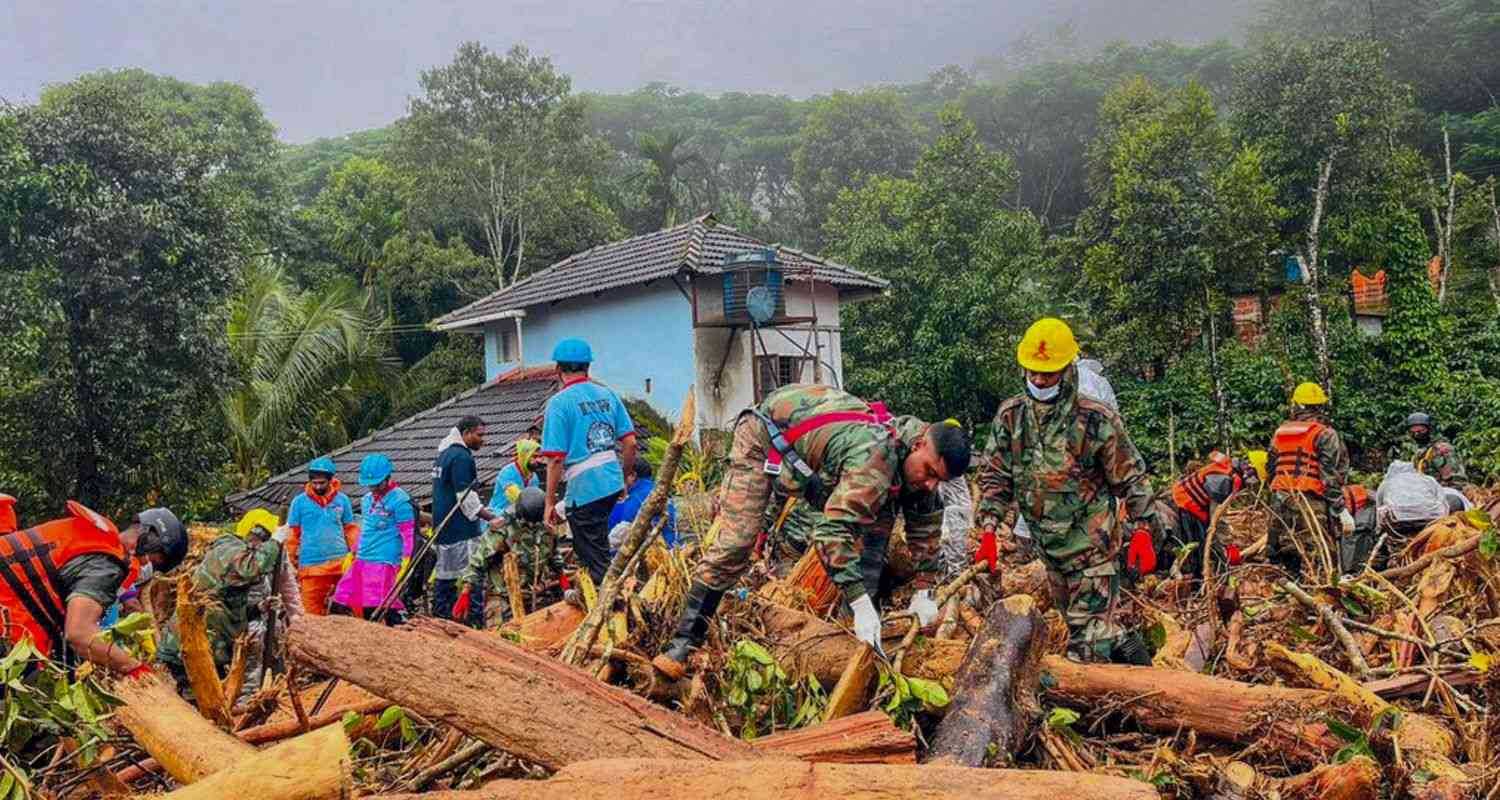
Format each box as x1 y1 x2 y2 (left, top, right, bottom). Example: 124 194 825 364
453 486 563 620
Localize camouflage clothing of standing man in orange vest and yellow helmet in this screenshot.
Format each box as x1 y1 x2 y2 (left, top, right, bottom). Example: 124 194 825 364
1266 408 1349 572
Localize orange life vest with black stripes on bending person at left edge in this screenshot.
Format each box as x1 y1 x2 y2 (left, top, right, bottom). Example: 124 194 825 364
0 500 134 657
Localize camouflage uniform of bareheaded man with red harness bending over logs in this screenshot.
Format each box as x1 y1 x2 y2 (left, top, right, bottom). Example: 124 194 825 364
695 384 942 602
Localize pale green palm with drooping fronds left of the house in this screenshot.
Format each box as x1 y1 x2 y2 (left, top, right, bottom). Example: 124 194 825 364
221 261 396 489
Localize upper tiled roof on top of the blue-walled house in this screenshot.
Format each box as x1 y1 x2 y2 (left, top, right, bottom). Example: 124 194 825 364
432 215 890 329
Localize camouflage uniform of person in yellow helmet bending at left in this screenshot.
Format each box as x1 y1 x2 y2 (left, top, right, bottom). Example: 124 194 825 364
156 533 281 683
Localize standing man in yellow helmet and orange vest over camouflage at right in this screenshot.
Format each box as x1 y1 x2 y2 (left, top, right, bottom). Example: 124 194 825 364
1266 383 1355 573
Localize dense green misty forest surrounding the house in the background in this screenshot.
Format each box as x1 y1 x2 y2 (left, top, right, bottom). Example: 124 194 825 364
0 0 1500 516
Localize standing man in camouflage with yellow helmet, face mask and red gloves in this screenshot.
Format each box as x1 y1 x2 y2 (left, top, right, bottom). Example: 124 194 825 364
975 317 1160 663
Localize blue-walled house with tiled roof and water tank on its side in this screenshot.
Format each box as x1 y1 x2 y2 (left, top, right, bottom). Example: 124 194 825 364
432 215 888 429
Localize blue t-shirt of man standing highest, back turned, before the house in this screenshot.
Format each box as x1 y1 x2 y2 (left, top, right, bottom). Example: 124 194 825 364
542 380 636 507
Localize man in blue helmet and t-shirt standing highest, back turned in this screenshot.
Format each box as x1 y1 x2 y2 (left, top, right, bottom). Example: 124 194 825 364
540 333 636 584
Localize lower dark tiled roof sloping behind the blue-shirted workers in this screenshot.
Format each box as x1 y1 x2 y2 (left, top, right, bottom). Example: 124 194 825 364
225 365 557 513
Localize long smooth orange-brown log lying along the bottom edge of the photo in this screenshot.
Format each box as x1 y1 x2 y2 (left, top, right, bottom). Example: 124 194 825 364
366 758 1158 800
